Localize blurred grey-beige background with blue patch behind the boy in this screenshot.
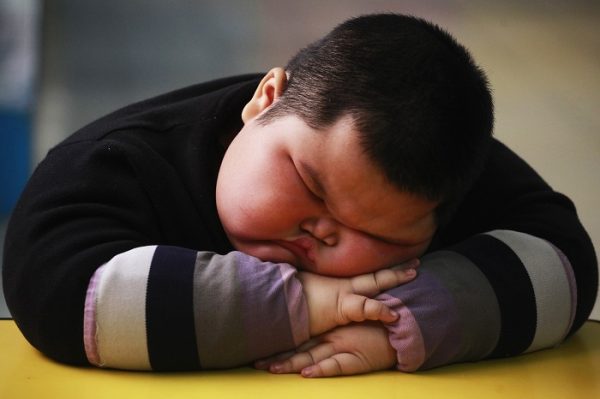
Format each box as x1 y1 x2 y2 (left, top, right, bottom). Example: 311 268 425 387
0 0 600 319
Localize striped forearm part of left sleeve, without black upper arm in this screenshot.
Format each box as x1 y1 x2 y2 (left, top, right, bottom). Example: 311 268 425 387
84 246 309 370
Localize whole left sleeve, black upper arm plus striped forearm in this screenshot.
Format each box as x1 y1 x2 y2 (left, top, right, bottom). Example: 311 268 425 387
3 136 309 370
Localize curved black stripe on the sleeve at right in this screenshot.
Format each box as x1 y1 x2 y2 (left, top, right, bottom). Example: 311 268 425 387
452 234 537 357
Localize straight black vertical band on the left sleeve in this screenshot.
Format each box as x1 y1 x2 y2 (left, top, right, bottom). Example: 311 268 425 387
146 246 200 370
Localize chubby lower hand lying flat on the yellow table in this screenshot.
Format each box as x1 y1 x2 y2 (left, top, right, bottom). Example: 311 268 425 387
255 322 396 377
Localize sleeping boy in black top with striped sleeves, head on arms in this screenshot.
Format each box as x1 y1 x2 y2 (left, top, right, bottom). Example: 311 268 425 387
3 14 597 377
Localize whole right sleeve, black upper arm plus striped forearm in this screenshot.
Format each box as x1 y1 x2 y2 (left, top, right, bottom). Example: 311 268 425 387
378 142 598 371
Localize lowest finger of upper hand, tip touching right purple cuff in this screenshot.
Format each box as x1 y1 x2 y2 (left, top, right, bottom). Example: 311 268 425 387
336 295 398 325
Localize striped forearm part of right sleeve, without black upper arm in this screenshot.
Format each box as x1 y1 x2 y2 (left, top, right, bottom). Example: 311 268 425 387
379 230 577 371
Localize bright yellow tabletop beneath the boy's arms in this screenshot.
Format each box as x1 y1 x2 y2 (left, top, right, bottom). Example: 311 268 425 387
0 320 600 399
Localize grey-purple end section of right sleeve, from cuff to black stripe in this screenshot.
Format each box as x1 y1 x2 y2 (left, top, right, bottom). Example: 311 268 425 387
378 251 501 371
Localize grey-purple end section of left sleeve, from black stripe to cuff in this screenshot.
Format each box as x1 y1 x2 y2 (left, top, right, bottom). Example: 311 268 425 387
194 251 309 368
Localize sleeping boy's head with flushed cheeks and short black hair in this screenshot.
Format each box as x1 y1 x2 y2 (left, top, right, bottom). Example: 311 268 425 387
217 14 493 275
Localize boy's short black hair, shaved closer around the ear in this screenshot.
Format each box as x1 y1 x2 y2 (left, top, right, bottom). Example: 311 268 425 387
259 14 494 222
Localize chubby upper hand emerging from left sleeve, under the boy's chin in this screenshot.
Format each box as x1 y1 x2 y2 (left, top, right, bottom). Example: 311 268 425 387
298 259 419 336
